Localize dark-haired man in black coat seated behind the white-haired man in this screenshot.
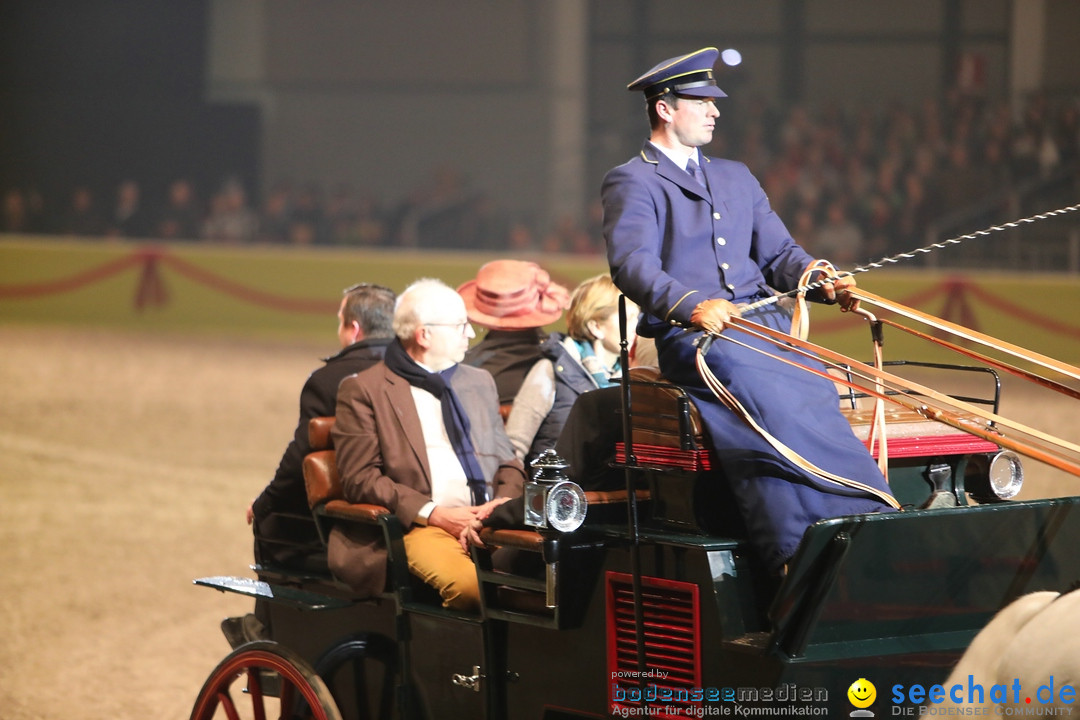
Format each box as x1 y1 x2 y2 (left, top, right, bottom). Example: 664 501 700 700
221 283 395 646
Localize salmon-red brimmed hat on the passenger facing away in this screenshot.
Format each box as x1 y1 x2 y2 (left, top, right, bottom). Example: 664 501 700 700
458 260 570 330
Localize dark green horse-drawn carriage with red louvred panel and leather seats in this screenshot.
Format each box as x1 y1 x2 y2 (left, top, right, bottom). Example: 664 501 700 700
191 296 1080 720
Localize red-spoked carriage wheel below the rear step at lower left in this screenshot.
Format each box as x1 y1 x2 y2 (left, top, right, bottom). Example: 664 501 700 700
191 641 341 720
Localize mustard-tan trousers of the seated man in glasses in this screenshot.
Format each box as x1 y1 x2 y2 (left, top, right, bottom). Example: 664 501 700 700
405 527 480 612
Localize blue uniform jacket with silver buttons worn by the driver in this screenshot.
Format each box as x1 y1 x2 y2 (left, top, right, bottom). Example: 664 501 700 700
603 142 813 328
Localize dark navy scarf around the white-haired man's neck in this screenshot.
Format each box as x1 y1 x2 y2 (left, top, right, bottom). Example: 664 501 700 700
382 339 487 505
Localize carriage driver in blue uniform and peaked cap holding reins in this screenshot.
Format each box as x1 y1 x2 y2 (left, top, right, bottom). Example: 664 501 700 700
603 47 895 572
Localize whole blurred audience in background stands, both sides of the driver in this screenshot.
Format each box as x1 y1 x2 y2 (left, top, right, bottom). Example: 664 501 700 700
6 87 1080 264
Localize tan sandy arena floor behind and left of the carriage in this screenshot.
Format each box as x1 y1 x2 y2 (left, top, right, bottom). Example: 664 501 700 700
0 324 1080 720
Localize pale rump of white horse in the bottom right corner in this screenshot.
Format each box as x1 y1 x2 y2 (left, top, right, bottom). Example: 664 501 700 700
936 592 1080 716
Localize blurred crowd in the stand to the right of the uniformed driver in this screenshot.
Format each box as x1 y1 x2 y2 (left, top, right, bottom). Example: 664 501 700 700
721 87 1080 264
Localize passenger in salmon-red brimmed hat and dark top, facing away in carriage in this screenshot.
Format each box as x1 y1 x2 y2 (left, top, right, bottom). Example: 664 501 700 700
458 260 569 405
